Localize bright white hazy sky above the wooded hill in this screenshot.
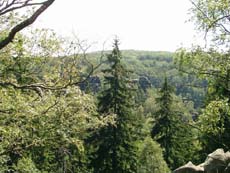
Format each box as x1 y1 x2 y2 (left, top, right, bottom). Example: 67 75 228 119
36 0 202 51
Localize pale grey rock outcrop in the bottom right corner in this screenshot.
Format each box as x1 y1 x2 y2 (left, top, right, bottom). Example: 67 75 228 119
173 149 230 173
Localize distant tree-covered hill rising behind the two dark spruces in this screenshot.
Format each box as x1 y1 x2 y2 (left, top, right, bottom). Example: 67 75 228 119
82 50 207 108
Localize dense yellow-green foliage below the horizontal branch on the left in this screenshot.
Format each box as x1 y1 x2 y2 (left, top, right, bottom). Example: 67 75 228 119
1 85 108 172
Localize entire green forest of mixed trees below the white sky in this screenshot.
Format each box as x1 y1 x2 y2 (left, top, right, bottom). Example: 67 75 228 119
0 0 230 173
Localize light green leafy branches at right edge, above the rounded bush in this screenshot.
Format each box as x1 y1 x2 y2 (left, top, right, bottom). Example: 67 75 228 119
179 0 230 90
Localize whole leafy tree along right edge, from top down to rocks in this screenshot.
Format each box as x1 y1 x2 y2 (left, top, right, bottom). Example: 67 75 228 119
176 0 230 157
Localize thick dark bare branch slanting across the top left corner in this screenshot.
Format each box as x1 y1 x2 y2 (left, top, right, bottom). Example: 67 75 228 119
0 0 55 50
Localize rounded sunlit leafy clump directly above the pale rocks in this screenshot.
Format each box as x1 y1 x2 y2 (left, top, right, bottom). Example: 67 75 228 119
197 99 230 156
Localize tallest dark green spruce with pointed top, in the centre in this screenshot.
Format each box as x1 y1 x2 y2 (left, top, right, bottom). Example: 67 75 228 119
92 39 136 173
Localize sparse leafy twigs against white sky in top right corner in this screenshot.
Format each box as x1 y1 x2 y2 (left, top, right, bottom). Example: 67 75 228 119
191 0 230 49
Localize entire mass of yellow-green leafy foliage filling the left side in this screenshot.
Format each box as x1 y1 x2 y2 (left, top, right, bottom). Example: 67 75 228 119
0 27 113 173
